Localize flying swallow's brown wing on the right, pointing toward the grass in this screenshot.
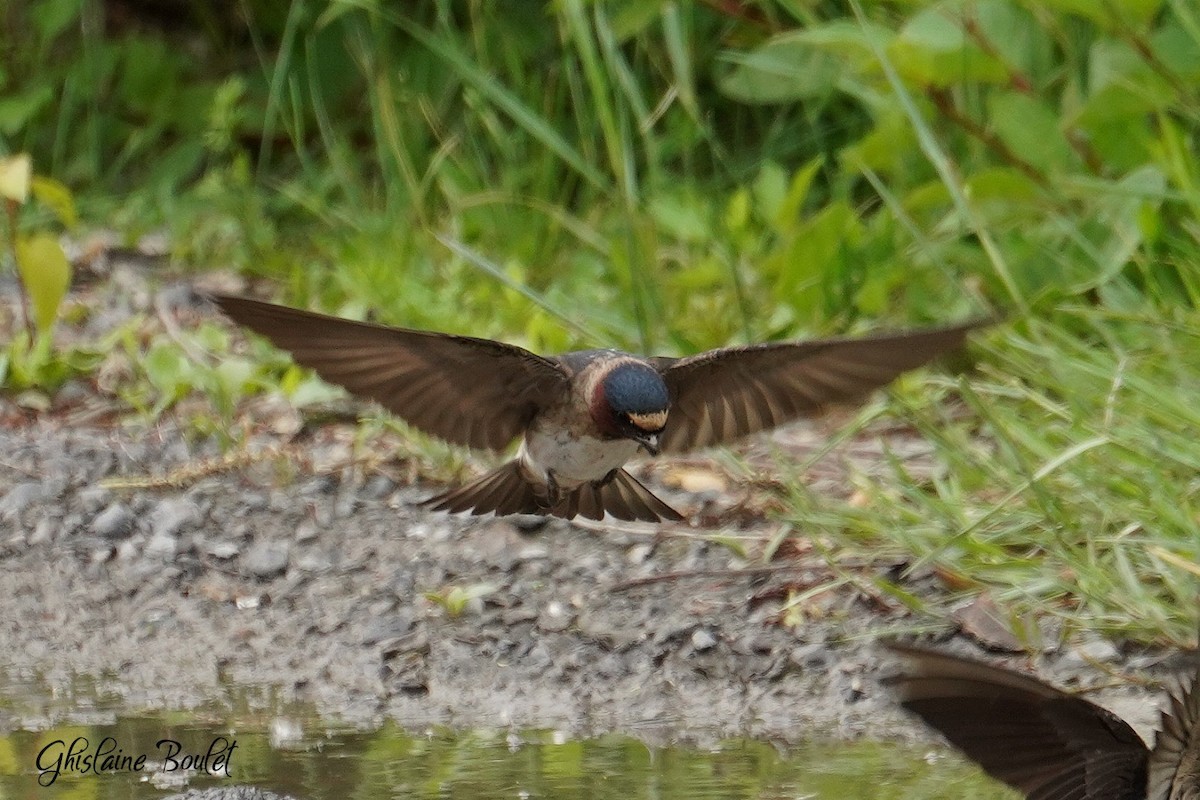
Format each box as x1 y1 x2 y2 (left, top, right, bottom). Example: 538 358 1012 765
652 321 989 452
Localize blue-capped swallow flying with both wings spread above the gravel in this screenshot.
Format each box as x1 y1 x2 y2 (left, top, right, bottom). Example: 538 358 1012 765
214 295 978 522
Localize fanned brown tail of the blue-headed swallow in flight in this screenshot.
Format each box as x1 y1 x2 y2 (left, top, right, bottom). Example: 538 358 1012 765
421 461 683 522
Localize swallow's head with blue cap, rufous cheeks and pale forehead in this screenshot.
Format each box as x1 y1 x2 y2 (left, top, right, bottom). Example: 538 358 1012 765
592 361 671 456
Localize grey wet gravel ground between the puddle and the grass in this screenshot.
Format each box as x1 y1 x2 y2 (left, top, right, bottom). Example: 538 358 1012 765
0 257 1180 741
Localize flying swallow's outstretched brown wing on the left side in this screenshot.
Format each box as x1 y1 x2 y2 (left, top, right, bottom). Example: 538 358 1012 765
212 295 568 450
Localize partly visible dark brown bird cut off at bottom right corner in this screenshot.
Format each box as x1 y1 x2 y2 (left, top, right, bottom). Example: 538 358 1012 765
887 644 1200 800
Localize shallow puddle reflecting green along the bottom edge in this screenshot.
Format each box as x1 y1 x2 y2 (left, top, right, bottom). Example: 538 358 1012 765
0 682 1016 800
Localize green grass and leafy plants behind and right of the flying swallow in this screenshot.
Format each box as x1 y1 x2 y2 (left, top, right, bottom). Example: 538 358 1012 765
0 0 1200 643
